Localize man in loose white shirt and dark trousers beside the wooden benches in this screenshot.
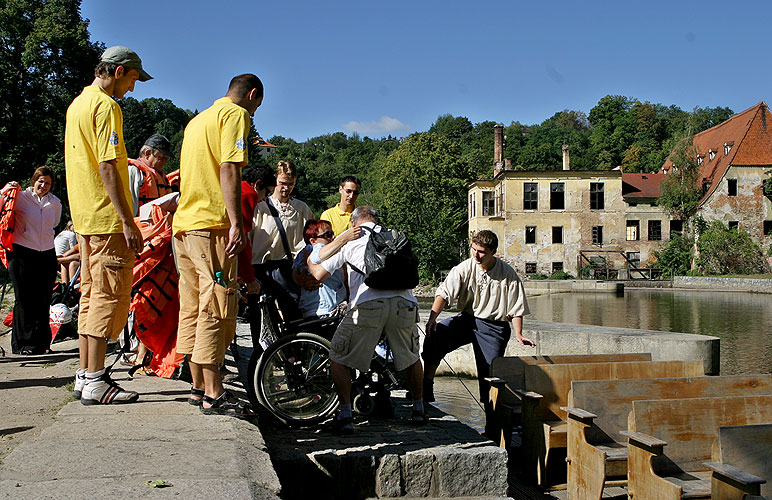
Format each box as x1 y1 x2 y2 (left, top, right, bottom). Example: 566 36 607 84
422 230 536 434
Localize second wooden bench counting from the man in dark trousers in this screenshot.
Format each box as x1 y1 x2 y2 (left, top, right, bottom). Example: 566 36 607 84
519 361 705 486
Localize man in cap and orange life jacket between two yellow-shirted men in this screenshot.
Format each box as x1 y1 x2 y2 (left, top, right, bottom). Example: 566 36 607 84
129 134 172 217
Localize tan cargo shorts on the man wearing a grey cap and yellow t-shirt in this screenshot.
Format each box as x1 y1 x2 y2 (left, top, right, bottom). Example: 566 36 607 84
78 233 134 340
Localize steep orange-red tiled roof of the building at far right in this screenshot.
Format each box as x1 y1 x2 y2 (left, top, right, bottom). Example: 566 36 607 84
662 101 772 203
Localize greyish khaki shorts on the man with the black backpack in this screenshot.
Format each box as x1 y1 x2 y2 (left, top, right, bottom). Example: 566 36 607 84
330 297 419 371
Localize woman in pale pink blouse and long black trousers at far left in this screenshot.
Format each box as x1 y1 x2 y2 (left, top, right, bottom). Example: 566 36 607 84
0 166 62 355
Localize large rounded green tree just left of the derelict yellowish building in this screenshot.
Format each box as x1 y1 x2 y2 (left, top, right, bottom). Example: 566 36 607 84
381 132 472 278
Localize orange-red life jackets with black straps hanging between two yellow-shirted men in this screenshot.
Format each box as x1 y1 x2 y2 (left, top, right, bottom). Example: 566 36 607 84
131 206 180 378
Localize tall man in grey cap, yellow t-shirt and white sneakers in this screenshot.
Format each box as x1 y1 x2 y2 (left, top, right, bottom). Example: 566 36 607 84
64 46 152 405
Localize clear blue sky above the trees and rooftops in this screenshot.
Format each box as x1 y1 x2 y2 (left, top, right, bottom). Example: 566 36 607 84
82 0 772 141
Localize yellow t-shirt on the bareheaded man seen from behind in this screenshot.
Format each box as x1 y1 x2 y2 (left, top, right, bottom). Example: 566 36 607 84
172 97 249 234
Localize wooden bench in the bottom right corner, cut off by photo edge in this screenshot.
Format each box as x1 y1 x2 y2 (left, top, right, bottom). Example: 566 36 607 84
704 424 772 500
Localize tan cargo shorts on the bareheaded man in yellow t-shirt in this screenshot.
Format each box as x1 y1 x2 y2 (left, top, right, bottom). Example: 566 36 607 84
174 229 238 365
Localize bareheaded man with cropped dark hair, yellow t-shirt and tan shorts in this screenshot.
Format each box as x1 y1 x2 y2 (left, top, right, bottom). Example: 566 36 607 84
172 74 263 418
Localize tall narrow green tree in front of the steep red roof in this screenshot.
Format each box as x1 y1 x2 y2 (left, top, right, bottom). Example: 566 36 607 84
659 137 702 223
